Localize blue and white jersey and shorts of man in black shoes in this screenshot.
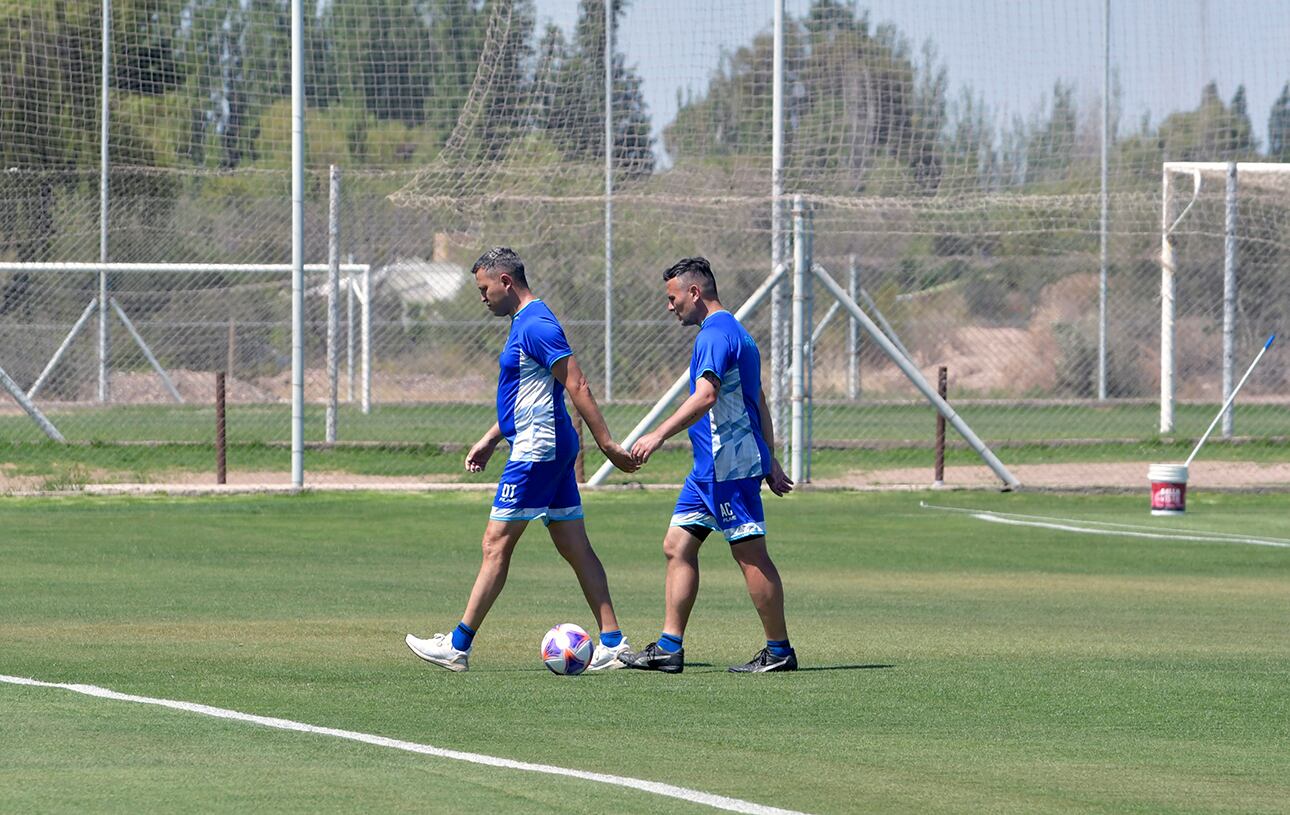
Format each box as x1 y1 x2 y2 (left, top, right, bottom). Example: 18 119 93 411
672 311 770 543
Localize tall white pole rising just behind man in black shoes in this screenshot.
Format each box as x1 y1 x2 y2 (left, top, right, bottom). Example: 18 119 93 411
770 0 789 458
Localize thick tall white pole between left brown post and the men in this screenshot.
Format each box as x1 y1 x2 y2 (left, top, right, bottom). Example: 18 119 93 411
292 0 304 487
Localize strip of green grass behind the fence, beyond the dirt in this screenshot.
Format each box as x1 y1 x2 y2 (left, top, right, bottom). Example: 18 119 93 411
0 404 1290 489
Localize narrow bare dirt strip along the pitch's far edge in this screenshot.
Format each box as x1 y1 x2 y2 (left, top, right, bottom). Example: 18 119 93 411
0 462 1290 495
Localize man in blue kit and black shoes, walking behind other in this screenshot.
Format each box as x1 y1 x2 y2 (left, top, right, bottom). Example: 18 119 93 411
618 258 797 673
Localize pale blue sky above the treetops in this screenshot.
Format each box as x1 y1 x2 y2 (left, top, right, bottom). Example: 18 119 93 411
537 0 1290 159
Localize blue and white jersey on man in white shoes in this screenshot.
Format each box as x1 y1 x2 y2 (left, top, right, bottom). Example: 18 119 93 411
497 300 578 462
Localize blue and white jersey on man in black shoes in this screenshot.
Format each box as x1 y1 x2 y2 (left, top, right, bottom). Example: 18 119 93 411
690 311 770 481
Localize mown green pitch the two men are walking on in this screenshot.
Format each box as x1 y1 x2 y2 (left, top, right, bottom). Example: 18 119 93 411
0 491 1290 812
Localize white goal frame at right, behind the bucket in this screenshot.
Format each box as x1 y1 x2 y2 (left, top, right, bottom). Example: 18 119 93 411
1160 161 1290 436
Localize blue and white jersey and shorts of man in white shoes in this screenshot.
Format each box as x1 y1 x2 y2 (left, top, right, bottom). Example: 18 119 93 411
489 299 582 524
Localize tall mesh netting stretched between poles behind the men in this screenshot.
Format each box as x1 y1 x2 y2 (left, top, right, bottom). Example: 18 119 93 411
0 0 1290 486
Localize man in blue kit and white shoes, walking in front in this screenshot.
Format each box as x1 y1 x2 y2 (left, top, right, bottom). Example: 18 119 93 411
405 246 637 671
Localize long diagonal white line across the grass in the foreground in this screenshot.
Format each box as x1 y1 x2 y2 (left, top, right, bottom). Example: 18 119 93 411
0 674 804 815
